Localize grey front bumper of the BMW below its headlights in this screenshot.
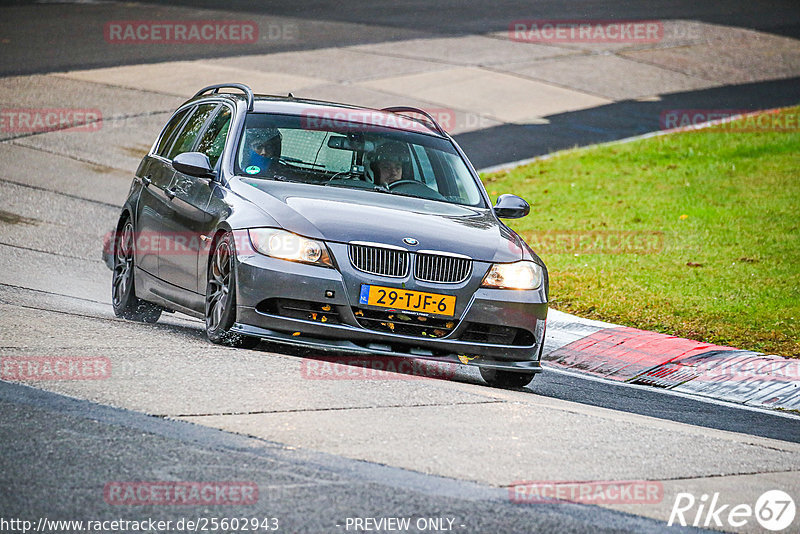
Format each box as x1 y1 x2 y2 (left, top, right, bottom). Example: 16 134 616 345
232 246 547 373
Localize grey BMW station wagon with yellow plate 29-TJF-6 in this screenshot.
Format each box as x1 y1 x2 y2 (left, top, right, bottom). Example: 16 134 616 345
111 84 548 387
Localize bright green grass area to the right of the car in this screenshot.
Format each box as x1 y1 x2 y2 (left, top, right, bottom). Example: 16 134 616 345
482 107 800 357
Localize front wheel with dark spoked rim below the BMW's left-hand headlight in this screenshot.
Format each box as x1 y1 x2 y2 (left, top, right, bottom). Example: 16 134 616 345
205 233 261 349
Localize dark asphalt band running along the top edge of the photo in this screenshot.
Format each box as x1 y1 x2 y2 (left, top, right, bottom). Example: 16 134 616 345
0 0 800 75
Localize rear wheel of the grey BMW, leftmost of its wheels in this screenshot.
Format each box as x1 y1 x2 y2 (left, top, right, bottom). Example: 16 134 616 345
111 219 163 323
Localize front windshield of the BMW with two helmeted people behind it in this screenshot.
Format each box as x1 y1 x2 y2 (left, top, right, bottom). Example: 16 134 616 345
228 113 485 207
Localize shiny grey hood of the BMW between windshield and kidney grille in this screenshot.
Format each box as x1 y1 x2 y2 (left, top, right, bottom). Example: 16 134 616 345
231 178 522 262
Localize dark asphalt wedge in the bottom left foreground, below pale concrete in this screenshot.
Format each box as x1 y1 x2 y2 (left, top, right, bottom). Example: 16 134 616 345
0 383 693 532
